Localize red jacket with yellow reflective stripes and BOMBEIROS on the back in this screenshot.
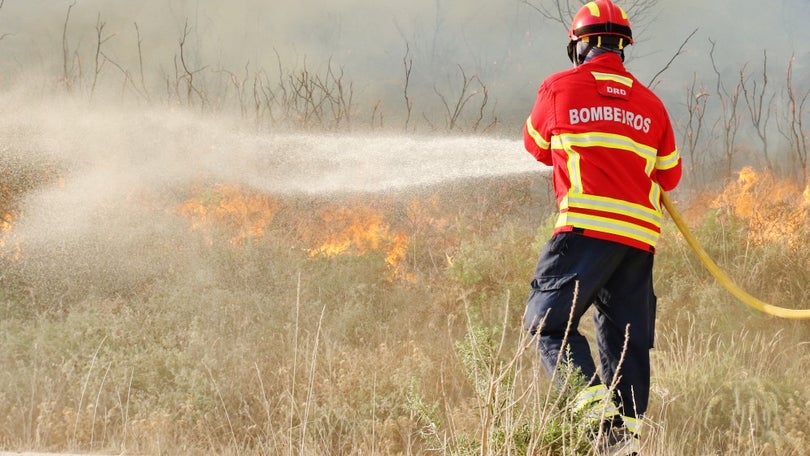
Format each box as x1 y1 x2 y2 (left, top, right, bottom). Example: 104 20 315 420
523 53 681 251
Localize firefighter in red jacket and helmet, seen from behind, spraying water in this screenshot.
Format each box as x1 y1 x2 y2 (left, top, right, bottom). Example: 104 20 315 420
523 0 681 455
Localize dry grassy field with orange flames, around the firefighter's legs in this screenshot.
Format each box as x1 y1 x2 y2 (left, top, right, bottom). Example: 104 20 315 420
0 161 810 456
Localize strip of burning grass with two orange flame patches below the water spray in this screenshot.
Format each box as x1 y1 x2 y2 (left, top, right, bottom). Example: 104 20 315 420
176 184 438 280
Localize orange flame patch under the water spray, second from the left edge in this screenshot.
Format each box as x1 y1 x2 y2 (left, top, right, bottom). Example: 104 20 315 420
178 184 278 245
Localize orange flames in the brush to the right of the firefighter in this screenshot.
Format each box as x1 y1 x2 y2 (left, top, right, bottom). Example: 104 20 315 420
712 167 810 248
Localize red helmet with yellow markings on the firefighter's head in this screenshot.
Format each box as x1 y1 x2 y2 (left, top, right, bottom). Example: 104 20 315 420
568 0 633 44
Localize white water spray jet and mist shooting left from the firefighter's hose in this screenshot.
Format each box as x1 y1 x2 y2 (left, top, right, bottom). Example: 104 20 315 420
0 88 536 300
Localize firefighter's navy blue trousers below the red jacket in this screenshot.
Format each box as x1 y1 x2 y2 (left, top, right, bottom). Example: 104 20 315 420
524 233 656 417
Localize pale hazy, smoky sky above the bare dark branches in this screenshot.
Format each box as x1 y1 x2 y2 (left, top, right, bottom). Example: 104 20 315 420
0 0 810 119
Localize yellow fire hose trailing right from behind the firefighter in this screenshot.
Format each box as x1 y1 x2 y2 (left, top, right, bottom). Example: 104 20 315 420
661 192 810 319
